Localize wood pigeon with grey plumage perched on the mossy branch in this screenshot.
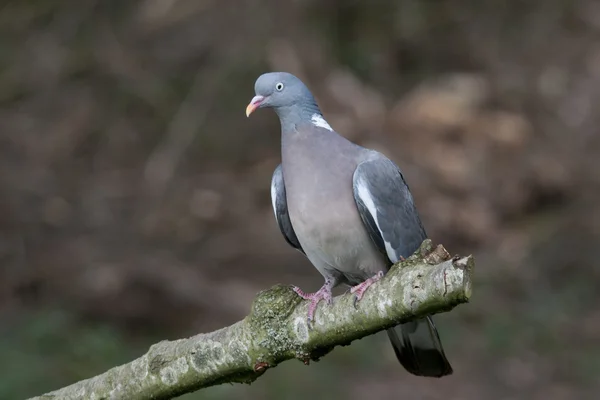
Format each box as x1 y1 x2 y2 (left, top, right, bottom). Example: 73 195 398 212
246 72 452 377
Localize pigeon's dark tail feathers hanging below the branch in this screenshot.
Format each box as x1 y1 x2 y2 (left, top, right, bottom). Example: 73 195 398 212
387 316 452 378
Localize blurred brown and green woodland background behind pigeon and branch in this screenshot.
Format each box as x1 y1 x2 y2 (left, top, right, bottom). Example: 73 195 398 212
0 0 600 400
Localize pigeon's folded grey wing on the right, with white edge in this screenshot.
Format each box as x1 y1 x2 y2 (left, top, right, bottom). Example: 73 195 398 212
352 155 427 263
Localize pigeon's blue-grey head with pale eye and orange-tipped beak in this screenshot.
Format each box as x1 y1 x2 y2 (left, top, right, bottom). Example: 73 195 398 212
246 72 322 131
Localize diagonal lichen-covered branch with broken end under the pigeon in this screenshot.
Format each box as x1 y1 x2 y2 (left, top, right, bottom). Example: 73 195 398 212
34 240 474 400
